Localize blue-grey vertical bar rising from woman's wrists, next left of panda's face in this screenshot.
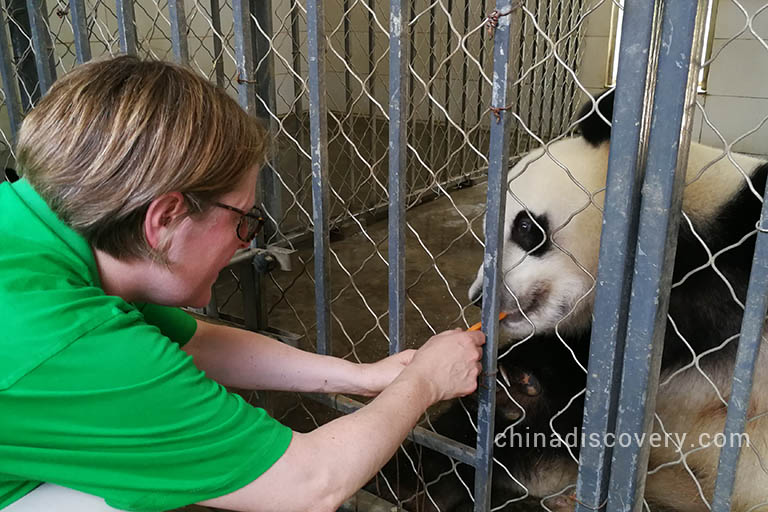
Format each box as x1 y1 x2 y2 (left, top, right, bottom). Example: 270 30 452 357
389 0 409 354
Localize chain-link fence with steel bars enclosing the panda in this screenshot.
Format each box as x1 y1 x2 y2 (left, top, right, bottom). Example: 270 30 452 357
0 0 768 511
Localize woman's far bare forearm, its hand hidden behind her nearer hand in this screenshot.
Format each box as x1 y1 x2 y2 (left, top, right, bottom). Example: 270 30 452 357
183 320 415 396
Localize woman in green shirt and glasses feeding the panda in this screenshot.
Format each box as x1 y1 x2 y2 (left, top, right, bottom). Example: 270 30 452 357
0 56 484 512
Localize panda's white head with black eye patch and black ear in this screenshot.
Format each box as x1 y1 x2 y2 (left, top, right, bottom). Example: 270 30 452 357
469 92 613 339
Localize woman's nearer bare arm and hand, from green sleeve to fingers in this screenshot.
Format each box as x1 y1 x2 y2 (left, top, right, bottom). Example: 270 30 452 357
201 331 485 512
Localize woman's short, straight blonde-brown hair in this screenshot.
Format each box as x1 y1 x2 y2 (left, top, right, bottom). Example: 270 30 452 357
17 56 268 261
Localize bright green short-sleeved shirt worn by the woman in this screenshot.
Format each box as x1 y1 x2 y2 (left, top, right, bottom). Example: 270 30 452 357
0 179 291 511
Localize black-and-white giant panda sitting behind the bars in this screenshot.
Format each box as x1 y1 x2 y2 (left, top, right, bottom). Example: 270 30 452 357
460 91 768 512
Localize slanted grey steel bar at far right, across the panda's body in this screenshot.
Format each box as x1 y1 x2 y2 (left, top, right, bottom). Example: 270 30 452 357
712 203 768 512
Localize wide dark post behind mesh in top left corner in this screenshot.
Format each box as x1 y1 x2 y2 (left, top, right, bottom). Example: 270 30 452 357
6 0 40 112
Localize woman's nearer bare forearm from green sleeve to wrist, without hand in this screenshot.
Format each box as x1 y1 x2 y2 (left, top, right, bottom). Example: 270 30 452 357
201 364 435 512
